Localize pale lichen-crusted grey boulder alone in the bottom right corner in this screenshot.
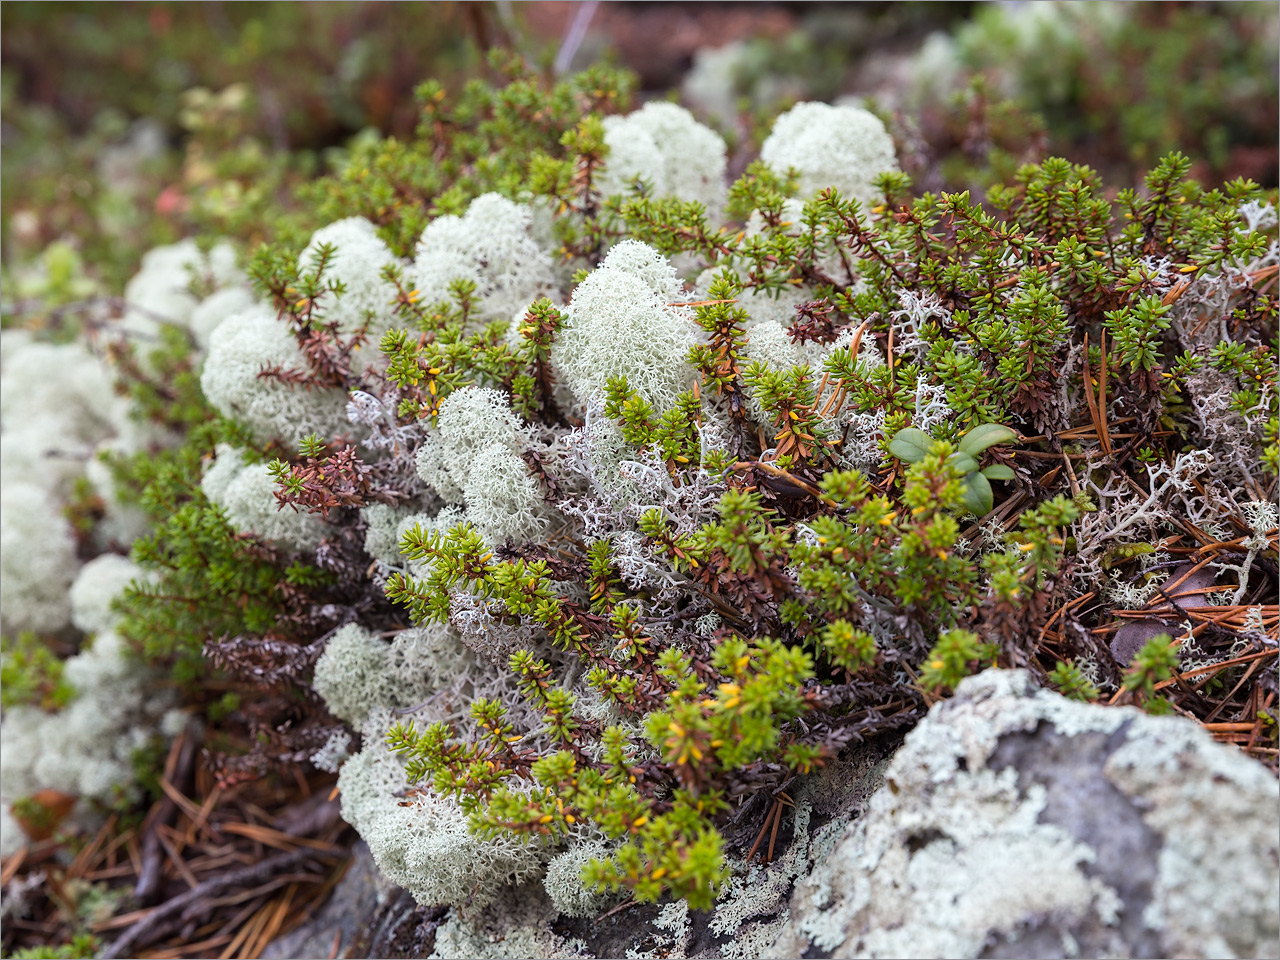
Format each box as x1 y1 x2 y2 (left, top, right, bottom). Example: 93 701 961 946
768 671 1280 957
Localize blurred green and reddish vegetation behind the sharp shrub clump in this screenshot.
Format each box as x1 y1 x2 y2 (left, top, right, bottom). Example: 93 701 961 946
0 1 1280 304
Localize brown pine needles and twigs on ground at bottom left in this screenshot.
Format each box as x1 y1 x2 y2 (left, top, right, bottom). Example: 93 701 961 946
0 728 355 960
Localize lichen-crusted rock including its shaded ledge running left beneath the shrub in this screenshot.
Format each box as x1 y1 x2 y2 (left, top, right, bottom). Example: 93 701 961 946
275 671 1280 959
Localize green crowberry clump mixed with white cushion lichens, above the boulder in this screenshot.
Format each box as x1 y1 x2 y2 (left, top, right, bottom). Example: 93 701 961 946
102 54 1277 909
